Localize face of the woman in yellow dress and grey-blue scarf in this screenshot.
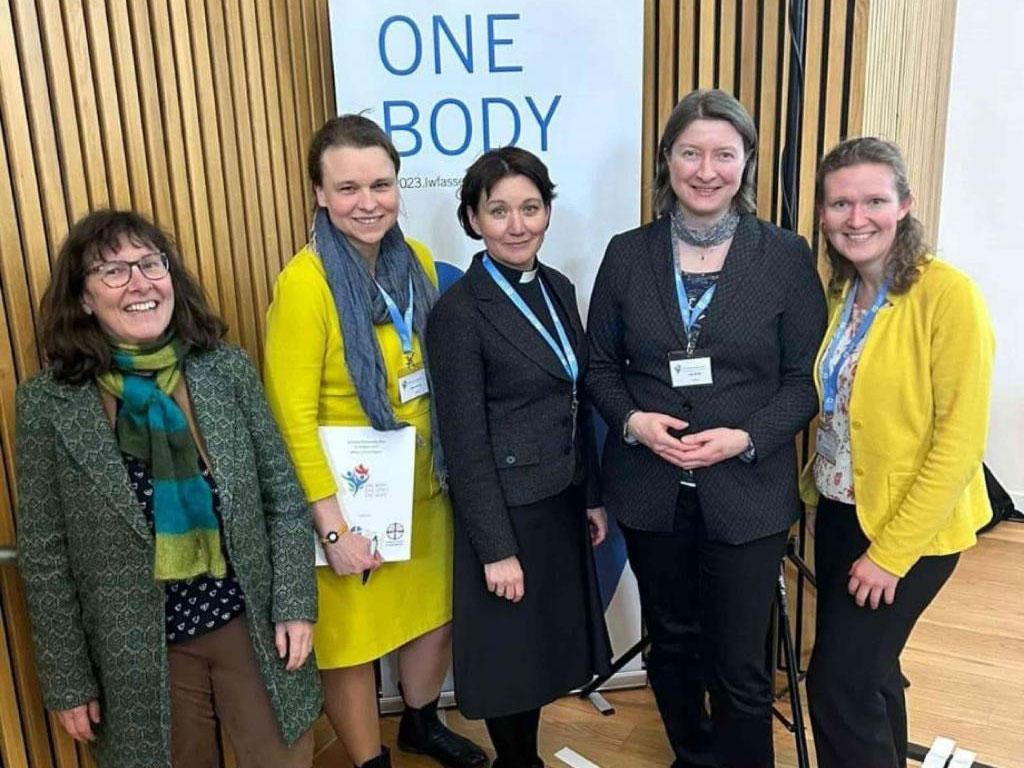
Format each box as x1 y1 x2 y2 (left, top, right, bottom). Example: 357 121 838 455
315 146 398 260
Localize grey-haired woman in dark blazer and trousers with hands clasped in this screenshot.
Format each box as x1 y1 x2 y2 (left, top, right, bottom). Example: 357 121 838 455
587 90 825 768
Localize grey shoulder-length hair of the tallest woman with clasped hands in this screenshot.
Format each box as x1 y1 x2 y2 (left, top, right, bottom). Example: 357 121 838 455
653 88 758 221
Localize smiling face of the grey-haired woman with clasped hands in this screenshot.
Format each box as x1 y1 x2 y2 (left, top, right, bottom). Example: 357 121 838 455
669 118 746 224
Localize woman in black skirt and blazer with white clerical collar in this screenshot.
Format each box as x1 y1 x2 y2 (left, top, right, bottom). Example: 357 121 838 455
427 147 610 768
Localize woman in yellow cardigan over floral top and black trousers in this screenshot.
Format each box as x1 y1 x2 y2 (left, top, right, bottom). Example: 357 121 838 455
805 138 993 768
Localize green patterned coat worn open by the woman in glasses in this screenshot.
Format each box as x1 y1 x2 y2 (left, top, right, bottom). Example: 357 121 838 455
16 345 321 768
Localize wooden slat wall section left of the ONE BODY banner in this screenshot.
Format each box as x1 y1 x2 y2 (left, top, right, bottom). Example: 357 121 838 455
0 0 334 768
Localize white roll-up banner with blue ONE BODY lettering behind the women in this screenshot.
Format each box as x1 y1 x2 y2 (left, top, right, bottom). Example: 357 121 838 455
330 0 643 703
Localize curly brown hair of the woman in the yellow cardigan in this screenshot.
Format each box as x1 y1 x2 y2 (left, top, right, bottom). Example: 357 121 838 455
814 136 931 294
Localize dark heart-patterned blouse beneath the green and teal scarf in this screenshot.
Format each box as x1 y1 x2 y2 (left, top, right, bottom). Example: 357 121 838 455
123 454 246 643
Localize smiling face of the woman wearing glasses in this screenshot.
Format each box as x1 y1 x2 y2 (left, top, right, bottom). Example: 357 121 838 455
82 238 174 344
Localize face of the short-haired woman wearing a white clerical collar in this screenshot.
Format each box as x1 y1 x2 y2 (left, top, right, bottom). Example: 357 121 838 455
469 174 551 269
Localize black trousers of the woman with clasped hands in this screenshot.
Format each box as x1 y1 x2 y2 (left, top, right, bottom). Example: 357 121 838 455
623 486 786 768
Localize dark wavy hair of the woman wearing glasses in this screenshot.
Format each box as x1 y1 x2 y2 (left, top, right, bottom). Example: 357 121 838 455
39 209 227 384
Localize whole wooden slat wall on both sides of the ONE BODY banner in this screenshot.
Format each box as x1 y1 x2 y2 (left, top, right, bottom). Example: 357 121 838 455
0 0 954 768
